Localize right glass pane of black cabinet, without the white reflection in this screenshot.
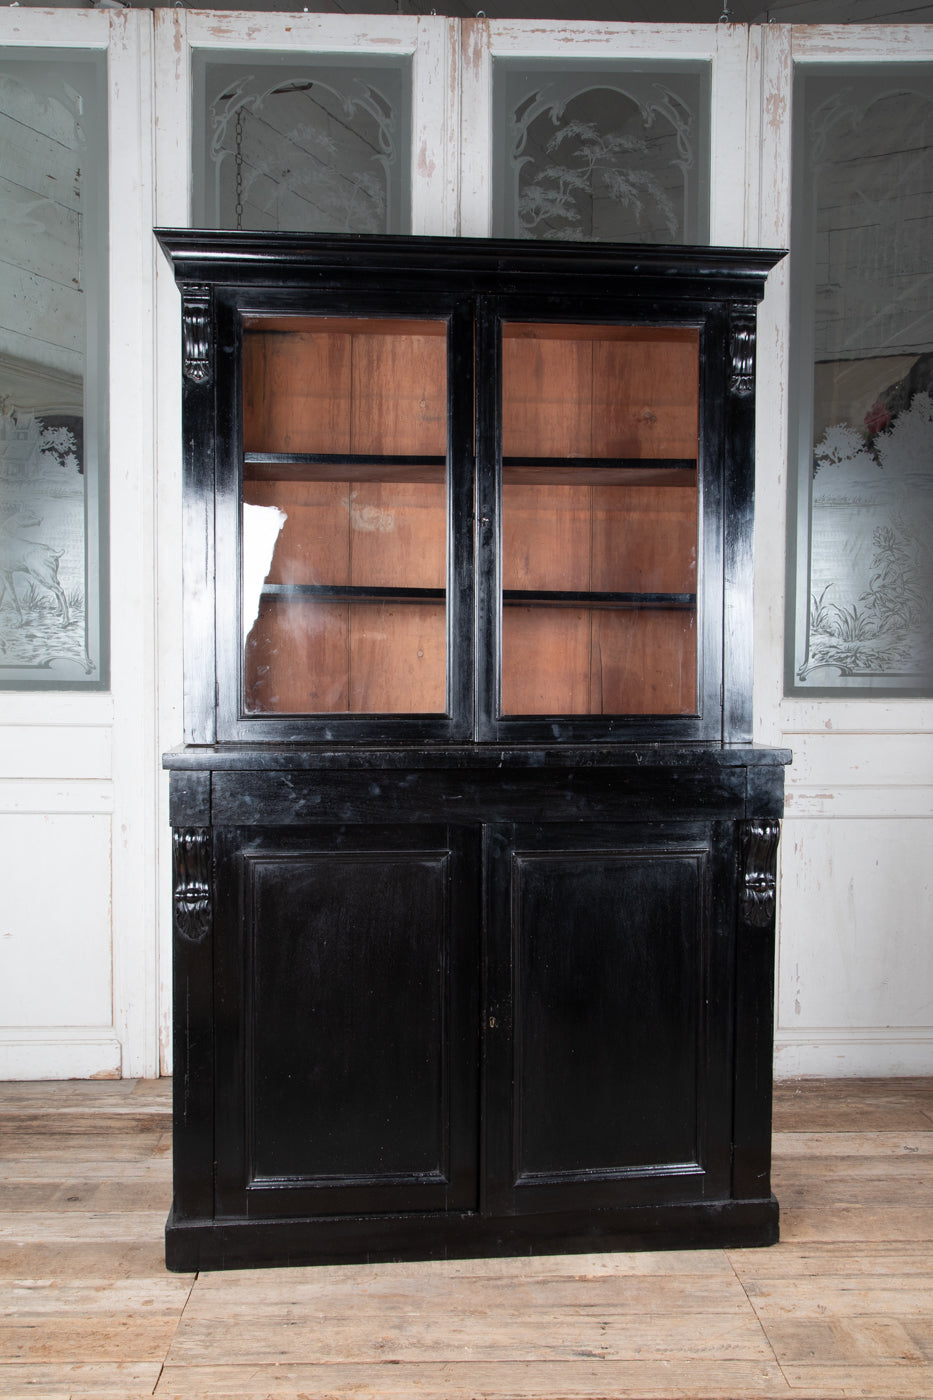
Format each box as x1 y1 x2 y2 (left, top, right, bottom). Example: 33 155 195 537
500 322 699 715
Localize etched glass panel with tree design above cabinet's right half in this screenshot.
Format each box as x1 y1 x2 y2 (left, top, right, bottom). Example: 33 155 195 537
493 59 709 244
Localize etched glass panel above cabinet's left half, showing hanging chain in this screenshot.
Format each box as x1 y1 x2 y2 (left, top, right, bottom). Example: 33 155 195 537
193 53 410 234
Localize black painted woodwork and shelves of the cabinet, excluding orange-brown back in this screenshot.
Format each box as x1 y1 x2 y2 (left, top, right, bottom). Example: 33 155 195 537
160 230 790 1270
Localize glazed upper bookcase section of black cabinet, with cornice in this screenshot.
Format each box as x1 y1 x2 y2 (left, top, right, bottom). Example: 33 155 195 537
157 230 782 749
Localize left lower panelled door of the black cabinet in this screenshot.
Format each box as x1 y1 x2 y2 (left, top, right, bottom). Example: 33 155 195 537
214 825 481 1218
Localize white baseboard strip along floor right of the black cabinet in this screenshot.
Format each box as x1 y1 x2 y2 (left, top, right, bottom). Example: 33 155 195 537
775 1026 933 1079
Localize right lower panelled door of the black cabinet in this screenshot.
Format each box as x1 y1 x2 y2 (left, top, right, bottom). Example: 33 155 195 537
485 822 734 1215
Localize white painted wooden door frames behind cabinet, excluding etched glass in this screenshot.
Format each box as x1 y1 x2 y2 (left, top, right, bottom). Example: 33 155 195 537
0 7 933 1078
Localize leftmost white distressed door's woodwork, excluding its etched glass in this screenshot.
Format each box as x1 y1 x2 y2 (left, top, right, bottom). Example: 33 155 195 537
0 8 160 1078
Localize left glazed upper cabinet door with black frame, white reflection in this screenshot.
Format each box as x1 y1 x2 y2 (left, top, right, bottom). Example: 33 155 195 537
216 293 474 742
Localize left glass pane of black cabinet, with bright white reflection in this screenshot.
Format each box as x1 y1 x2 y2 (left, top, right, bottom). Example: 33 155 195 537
241 318 447 714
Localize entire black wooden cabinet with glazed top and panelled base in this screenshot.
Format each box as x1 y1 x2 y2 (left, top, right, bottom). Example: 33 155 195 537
160 231 789 1268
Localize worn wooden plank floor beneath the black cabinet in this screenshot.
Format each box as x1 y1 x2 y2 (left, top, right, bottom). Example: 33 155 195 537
0 1079 933 1400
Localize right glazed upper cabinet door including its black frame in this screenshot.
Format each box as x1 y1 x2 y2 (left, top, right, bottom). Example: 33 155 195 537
478 298 724 742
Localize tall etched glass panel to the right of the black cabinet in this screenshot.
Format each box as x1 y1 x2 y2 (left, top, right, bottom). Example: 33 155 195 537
787 64 933 694
